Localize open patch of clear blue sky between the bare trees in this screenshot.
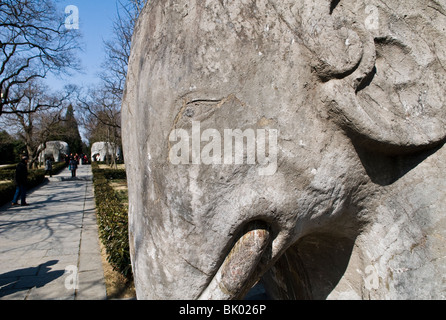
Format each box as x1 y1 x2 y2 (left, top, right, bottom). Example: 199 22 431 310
47 0 117 90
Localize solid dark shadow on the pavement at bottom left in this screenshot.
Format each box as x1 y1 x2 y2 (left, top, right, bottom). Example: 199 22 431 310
0 260 65 298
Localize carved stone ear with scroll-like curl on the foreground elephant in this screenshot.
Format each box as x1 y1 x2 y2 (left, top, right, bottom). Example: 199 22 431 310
273 0 446 154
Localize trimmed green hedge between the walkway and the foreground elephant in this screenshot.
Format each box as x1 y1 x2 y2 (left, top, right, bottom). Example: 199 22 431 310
92 163 132 279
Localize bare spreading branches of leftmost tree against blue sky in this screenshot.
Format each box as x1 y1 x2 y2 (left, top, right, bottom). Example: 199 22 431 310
0 0 79 116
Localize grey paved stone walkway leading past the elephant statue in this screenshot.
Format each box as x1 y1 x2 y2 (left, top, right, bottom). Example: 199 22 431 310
0 166 106 300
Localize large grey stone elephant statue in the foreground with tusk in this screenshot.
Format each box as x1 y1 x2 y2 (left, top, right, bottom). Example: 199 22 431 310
122 0 446 299
